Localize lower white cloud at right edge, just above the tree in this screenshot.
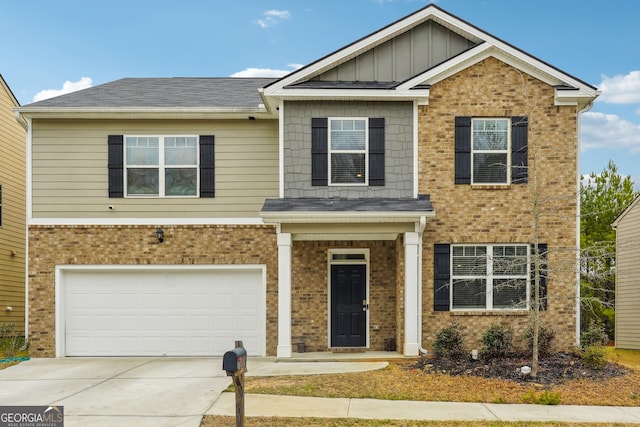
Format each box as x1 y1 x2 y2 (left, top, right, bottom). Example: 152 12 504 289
580 111 640 154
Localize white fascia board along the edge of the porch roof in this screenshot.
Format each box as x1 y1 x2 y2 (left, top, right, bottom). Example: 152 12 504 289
260 211 435 224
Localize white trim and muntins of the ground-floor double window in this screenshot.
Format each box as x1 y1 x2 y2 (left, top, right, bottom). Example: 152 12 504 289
449 243 531 312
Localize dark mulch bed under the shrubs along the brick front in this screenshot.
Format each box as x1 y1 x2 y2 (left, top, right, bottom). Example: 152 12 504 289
413 352 629 385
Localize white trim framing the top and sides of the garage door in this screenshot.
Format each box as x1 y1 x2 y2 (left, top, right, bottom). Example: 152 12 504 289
54 264 267 357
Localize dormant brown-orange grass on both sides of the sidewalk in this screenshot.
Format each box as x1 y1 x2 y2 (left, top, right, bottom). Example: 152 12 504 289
202 348 640 427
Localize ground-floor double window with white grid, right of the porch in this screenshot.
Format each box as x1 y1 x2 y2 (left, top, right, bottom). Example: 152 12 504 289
451 245 530 310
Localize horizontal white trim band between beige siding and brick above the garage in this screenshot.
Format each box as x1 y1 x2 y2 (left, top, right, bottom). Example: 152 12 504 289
27 217 268 226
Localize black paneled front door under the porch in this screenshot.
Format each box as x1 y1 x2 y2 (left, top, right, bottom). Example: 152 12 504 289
331 264 368 347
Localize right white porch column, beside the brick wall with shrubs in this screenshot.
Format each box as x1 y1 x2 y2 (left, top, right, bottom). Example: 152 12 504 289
404 232 420 356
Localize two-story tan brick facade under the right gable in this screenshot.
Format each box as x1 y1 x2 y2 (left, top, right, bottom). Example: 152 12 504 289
419 58 577 350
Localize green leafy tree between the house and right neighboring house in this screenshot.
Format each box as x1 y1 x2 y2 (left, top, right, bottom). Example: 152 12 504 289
580 161 639 337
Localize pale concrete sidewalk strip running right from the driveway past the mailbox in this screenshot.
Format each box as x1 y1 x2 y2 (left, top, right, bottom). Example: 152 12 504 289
206 393 640 423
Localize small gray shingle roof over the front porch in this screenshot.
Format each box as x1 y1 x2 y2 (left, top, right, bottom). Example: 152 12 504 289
262 195 433 213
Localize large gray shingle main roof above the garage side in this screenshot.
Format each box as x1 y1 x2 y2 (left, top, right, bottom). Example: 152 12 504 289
24 77 277 108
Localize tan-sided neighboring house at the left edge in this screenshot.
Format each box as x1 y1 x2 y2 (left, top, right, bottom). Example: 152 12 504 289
0 75 27 333
